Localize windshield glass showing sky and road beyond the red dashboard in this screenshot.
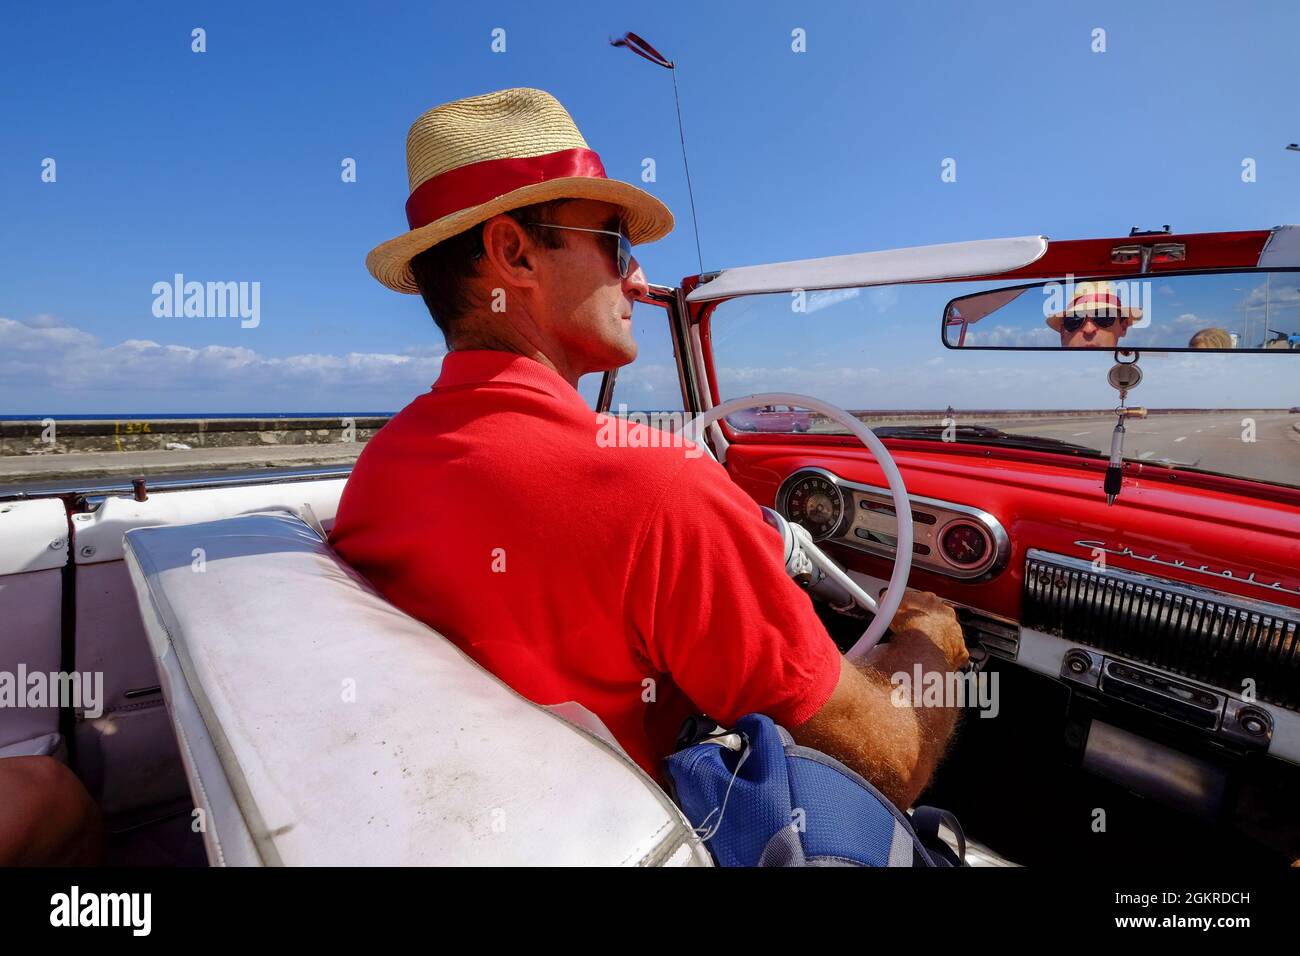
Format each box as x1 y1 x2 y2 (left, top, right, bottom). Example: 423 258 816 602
709 282 1300 486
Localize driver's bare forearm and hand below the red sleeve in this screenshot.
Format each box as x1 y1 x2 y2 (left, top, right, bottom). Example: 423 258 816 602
789 591 967 809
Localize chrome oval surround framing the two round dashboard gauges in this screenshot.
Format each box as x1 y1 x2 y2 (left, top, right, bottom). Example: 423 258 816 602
776 466 1011 581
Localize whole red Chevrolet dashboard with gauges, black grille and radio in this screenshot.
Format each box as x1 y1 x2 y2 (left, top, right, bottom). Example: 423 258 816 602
743 444 1300 765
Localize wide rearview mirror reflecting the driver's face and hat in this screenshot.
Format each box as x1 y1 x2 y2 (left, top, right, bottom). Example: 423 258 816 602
943 269 1300 352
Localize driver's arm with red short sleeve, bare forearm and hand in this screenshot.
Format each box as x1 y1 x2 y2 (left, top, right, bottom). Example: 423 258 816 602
625 459 966 808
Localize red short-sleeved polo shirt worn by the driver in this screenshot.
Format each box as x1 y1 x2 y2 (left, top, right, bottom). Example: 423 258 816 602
330 351 840 779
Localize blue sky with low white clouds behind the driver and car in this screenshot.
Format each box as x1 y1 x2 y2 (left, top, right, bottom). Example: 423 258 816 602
0 1 1300 415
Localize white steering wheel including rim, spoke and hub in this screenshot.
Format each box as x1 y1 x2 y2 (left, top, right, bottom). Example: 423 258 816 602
683 392 911 661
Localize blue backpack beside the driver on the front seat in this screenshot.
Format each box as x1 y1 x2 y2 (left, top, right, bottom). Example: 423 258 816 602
667 714 966 866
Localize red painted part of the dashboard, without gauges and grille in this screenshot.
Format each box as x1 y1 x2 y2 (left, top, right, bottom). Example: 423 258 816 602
727 436 1300 620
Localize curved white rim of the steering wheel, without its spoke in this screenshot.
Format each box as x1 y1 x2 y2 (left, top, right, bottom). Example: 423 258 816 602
683 392 913 661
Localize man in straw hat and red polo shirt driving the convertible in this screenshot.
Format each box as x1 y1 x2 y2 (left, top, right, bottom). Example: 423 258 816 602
332 88 967 808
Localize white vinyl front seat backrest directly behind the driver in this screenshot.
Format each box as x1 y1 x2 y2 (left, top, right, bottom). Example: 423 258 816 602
126 512 709 865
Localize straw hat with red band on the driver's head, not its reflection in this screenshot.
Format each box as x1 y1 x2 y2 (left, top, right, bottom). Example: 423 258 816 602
365 88 672 293
